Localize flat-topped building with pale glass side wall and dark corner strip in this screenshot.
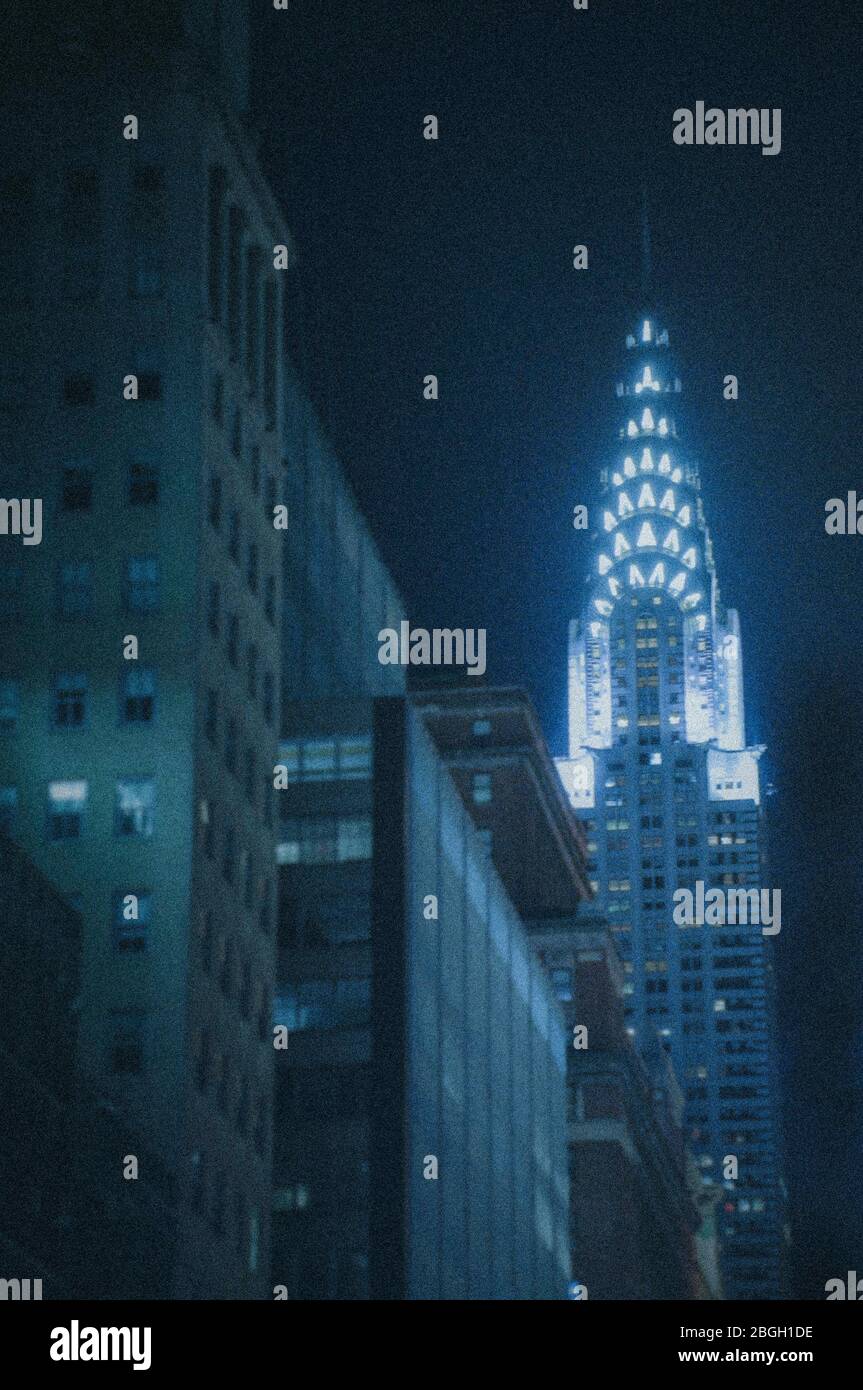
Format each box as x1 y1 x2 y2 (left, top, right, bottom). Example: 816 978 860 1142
274 696 568 1298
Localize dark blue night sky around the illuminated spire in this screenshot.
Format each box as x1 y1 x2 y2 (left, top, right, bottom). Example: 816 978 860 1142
252 0 863 1298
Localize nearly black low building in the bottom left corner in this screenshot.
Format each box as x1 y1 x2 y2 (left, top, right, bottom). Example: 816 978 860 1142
0 837 175 1300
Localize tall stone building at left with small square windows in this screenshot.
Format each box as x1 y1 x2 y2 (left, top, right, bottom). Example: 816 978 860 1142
0 0 289 1298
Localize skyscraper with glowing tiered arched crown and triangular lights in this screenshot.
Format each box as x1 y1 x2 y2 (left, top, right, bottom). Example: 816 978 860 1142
559 316 784 1298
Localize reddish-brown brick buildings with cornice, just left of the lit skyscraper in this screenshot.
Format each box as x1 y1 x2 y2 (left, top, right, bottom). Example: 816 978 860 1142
414 682 720 1300
